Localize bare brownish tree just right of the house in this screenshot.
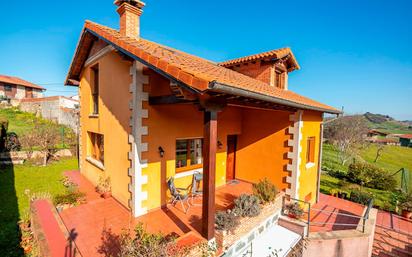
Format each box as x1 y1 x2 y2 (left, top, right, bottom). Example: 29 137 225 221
324 115 368 165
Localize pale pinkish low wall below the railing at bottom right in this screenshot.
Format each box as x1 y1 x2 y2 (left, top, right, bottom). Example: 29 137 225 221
303 209 377 257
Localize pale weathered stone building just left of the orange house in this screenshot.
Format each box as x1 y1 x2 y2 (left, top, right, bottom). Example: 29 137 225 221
19 96 79 132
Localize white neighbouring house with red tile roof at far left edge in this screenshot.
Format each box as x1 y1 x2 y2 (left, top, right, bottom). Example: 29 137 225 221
0 75 46 100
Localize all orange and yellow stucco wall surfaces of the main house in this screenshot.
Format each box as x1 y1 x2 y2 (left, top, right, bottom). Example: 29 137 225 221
80 50 321 210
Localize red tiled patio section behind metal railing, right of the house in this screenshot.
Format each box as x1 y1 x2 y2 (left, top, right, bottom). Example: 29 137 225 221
304 194 365 232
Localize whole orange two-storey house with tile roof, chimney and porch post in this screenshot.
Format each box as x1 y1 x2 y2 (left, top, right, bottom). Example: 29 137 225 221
65 0 340 248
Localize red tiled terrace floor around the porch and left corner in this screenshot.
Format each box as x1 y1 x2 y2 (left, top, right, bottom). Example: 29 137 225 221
60 177 252 257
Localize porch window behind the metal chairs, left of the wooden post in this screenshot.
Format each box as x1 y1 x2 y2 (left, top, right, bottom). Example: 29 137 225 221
176 138 202 172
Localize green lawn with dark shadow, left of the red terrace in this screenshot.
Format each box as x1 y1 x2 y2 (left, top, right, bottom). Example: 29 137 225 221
0 158 77 257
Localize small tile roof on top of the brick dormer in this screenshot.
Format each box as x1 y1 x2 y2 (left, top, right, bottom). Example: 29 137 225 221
219 47 300 70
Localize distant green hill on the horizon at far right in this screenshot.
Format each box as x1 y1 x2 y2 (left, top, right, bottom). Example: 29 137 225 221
363 112 412 134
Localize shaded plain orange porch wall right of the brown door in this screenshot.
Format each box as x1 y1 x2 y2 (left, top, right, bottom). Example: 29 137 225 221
236 109 291 189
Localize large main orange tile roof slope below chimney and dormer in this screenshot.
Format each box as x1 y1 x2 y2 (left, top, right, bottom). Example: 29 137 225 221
66 21 340 113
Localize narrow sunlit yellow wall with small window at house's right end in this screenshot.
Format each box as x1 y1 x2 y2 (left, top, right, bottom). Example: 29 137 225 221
298 111 322 203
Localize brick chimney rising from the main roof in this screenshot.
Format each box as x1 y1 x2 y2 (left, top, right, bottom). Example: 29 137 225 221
114 0 145 39
